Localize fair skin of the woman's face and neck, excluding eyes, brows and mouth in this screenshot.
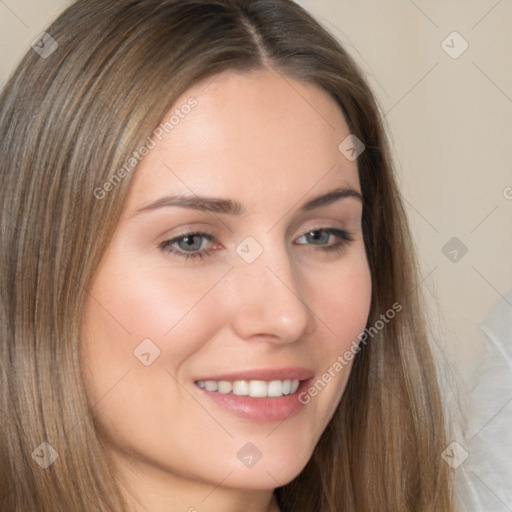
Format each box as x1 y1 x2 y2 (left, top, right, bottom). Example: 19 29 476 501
80 71 371 512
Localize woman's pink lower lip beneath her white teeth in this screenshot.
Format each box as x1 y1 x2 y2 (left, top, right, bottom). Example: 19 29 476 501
194 379 312 422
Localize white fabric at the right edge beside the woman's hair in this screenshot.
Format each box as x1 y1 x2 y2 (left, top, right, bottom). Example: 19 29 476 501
456 292 512 512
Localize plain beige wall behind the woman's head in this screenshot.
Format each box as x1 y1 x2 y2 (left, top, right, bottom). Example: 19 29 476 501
0 0 512 388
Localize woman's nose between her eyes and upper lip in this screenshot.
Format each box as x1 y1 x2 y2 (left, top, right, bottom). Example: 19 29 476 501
230 239 315 344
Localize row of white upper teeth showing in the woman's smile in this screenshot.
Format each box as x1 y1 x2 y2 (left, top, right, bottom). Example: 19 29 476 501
196 379 300 398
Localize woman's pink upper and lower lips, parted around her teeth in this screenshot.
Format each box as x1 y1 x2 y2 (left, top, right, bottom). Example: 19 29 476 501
193 368 313 422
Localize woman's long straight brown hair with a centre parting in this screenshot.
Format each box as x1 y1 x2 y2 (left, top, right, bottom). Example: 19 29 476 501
0 0 453 512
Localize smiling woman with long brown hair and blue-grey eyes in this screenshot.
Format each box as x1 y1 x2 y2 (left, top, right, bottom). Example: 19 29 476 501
0 0 453 512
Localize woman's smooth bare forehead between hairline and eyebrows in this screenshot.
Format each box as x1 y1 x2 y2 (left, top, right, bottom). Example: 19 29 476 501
122 71 359 212
